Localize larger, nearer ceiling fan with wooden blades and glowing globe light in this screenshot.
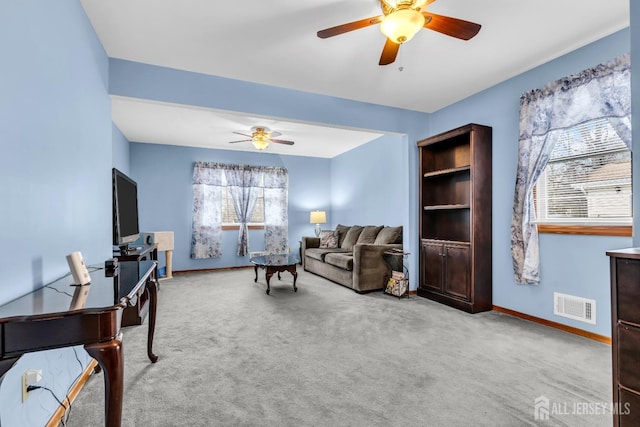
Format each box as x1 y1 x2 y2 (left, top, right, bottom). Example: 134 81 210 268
318 0 481 65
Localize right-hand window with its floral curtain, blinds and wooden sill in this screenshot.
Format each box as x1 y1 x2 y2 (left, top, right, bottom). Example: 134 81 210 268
511 53 631 285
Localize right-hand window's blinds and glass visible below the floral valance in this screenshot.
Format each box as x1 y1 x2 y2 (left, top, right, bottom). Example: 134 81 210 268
534 119 632 226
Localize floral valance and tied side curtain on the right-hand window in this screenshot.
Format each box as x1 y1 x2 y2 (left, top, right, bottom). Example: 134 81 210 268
511 54 631 284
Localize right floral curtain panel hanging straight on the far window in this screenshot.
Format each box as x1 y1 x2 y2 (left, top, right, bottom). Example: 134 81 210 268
263 168 289 253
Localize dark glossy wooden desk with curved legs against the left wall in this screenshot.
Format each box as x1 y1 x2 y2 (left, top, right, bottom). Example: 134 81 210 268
0 261 158 427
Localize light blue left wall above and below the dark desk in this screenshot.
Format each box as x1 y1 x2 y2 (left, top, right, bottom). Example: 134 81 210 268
0 0 111 426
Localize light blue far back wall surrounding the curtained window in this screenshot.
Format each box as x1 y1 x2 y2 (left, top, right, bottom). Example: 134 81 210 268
129 143 330 271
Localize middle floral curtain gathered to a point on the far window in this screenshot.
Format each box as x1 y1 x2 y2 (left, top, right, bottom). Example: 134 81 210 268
224 165 262 256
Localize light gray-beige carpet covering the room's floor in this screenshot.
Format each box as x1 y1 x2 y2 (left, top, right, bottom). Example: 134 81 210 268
62 269 612 427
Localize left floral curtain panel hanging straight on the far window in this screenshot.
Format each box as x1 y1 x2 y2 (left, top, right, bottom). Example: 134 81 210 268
191 162 224 259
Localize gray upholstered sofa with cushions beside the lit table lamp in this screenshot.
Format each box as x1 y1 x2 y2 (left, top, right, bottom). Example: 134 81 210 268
300 225 402 293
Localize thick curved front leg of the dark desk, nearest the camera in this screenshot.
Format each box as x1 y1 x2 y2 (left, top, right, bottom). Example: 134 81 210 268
84 332 124 427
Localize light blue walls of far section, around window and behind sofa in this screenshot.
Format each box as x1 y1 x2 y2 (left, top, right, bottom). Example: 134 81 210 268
129 132 406 271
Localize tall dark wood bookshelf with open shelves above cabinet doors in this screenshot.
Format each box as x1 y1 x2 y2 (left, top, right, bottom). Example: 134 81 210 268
417 124 492 313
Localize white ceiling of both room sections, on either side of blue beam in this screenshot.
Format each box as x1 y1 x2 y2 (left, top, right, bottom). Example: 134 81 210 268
81 0 629 157
